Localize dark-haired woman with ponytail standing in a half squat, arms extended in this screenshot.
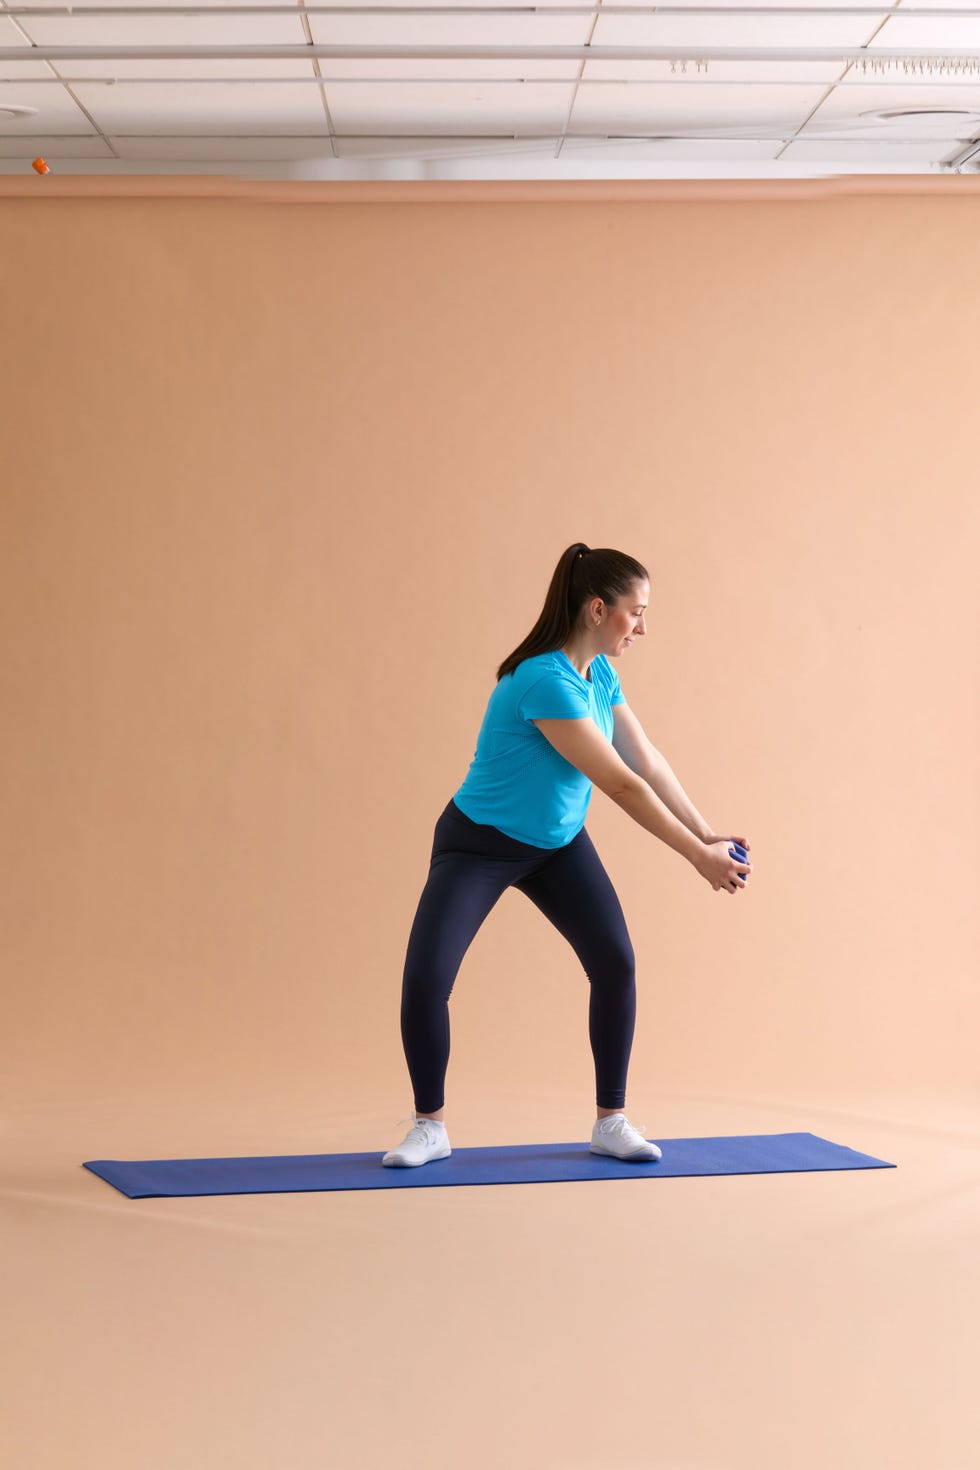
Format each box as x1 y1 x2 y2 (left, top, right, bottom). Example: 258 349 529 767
383 542 752 1166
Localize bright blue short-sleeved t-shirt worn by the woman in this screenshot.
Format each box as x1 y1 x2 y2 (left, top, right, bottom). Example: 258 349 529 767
453 648 626 848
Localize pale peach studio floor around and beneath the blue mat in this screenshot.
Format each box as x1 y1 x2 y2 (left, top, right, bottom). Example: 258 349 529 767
0 1091 980 1470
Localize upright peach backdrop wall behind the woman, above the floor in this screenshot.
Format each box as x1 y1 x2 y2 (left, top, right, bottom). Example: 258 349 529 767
0 185 980 1123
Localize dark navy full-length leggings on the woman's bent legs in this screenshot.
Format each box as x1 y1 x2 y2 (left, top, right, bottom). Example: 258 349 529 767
401 798 636 1113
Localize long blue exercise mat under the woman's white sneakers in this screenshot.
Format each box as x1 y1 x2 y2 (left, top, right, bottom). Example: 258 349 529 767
85 1133 898 1200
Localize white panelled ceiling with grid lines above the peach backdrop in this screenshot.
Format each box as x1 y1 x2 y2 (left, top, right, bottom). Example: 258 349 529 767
0 0 980 178
